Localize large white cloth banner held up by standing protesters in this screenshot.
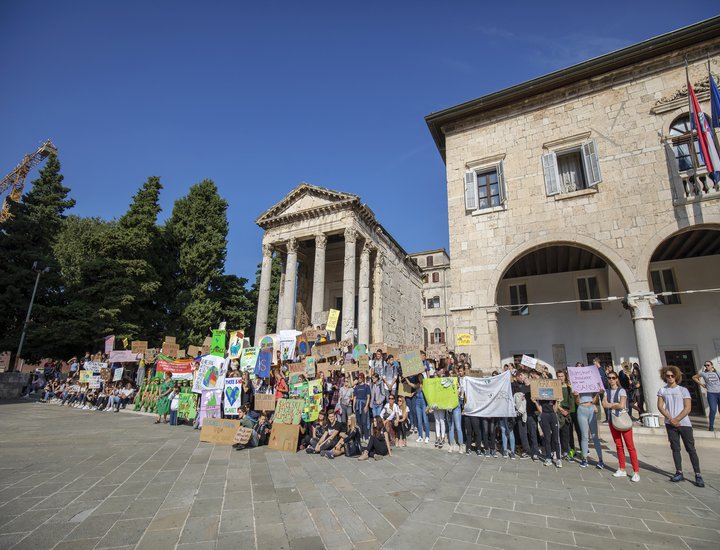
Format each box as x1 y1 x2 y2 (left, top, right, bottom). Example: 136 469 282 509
462 371 516 417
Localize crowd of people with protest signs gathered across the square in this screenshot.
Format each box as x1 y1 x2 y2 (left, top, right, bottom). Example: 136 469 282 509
21 350 720 487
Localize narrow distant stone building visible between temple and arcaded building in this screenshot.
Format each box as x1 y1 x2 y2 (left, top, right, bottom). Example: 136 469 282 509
410 248 453 349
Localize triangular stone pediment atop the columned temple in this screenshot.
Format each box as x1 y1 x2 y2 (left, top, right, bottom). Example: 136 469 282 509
256 182 360 227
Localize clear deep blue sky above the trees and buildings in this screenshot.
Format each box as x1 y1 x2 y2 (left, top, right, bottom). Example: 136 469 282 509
0 0 718 279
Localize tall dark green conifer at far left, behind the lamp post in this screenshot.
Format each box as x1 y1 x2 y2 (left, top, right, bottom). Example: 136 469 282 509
0 155 75 360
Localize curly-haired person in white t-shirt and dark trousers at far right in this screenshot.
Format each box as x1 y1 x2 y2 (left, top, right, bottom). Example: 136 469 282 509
657 365 705 487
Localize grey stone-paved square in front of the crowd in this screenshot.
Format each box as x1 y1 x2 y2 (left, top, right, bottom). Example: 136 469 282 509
0 402 720 550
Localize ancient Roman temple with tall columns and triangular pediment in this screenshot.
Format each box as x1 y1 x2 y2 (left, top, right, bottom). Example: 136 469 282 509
255 183 422 346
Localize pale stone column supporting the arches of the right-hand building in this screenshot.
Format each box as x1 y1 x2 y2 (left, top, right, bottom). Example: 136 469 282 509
627 292 663 414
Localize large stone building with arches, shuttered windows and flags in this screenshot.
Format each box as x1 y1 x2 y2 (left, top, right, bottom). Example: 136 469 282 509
426 17 720 418
